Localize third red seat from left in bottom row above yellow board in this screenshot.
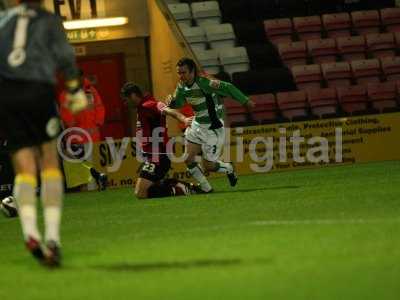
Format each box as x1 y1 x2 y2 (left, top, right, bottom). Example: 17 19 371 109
276 91 308 121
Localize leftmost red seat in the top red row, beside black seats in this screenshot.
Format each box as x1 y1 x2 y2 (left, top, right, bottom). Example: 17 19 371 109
264 18 293 44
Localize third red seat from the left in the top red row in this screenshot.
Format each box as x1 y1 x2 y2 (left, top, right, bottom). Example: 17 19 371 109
322 13 351 38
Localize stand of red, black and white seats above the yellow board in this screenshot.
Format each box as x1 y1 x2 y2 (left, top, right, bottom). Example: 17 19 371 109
166 0 400 125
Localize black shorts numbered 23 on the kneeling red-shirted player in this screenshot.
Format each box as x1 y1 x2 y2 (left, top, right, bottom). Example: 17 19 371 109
138 154 171 182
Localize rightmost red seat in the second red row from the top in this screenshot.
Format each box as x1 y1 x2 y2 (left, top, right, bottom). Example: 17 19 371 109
366 32 396 58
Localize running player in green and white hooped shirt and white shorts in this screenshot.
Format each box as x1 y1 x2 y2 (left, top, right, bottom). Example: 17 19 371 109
167 58 254 193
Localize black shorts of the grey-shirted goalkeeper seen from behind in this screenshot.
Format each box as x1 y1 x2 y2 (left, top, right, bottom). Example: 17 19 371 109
0 78 60 151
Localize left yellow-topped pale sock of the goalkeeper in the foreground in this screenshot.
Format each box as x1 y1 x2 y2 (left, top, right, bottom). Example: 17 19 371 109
13 174 41 241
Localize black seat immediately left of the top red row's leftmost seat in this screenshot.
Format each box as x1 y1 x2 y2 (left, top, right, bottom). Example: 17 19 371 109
233 21 267 46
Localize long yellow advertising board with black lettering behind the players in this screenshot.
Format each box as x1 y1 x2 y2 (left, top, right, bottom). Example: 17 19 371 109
88 113 400 188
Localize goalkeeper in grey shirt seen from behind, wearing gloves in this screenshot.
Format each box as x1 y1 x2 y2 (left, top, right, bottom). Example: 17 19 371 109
0 0 87 266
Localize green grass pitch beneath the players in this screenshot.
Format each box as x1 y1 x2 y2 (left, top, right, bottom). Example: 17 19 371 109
0 162 400 300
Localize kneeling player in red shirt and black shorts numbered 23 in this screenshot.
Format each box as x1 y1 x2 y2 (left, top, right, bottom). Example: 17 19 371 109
121 82 198 199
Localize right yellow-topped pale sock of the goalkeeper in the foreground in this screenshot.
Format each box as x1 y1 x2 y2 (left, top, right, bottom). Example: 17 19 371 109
41 169 63 243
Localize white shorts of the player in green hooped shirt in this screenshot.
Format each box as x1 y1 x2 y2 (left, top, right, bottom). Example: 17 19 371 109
185 122 225 162
